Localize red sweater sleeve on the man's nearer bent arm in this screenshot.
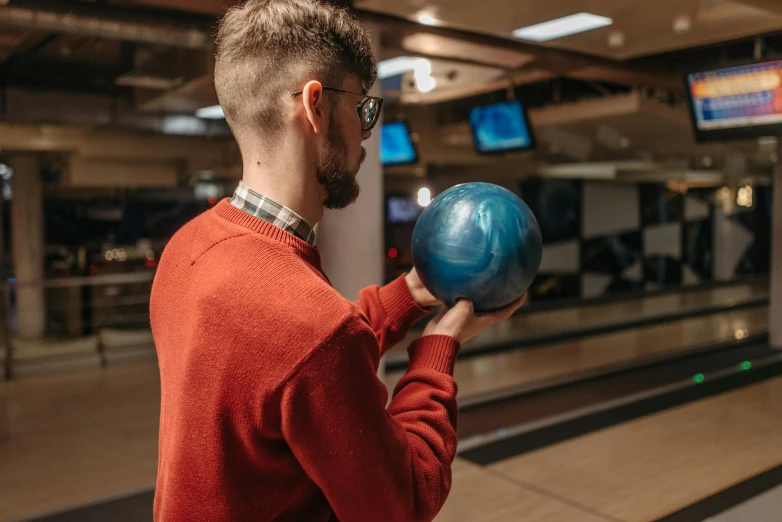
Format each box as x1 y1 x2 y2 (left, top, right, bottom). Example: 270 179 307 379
282 318 459 522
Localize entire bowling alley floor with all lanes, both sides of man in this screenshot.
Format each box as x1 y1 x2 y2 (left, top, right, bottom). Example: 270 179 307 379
0 280 782 522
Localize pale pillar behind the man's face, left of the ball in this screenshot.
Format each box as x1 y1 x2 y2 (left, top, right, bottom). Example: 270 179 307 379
317 25 384 370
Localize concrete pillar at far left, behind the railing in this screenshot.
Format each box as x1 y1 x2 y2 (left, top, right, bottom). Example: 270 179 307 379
10 154 46 339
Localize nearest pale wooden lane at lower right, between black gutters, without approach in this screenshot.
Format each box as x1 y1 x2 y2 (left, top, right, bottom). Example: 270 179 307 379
488 372 782 522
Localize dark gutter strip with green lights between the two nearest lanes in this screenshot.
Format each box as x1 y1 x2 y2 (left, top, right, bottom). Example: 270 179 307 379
458 341 782 444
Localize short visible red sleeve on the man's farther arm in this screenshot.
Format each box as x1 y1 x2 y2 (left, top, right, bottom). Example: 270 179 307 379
353 274 431 357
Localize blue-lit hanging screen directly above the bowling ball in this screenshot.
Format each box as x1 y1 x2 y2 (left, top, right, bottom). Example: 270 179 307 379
470 101 534 154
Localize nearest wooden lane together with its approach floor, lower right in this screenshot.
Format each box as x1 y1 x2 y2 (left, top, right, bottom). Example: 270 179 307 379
437 378 782 522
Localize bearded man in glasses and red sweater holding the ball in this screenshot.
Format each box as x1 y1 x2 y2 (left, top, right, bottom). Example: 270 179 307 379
150 0 520 522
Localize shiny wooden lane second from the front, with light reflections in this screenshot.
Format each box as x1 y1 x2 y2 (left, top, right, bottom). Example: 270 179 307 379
384 306 768 404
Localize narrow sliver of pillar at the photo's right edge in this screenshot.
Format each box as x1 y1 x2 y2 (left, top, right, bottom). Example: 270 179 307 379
768 138 782 349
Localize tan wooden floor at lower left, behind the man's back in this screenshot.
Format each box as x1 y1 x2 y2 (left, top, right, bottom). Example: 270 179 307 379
0 363 160 521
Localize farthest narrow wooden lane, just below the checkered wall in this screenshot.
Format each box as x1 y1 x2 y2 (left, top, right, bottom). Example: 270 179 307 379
387 282 768 370
